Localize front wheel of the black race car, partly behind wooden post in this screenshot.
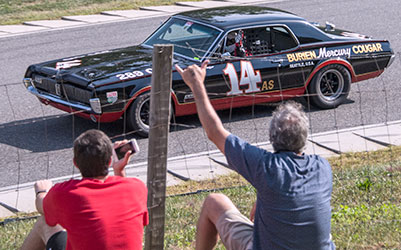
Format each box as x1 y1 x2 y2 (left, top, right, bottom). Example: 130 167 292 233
127 92 174 137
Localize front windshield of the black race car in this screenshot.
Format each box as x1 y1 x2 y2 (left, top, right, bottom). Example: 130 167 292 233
143 18 221 60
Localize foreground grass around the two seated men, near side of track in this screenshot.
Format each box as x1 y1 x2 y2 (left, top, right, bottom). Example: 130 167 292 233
0 147 401 250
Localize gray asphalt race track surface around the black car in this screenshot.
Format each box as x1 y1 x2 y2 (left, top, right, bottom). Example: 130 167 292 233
0 0 401 188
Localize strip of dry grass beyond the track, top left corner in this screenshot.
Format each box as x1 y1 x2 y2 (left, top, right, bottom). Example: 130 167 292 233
0 0 199 25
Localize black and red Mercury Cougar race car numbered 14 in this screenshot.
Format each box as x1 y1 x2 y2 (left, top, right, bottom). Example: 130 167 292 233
24 6 394 136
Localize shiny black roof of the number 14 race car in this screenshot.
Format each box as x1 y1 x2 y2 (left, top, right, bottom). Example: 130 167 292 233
174 6 305 30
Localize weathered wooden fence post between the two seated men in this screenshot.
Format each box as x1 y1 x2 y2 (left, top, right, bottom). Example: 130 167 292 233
145 44 173 250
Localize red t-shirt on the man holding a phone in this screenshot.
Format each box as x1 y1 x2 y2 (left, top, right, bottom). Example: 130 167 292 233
43 176 148 250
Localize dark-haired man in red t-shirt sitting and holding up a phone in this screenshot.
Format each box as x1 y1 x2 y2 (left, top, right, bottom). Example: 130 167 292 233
21 130 148 250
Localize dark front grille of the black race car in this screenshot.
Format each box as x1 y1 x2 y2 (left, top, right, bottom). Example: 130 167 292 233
33 75 92 104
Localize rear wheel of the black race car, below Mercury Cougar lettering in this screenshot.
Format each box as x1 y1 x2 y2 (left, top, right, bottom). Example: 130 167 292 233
308 64 351 109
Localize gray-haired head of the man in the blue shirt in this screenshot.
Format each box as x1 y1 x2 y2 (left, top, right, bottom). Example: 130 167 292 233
269 101 309 154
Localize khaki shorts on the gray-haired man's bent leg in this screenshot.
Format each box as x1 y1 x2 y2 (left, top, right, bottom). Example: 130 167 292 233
216 209 253 250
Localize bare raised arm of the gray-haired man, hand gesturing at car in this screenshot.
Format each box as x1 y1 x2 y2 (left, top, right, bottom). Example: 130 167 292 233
175 60 230 154
